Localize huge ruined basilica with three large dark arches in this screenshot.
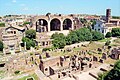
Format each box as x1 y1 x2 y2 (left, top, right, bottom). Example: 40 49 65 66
31 14 80 33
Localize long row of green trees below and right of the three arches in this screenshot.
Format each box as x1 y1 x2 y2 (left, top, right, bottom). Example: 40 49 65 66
51 28 104 48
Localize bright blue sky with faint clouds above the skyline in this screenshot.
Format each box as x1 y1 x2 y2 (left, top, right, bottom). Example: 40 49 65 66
0 0 120 16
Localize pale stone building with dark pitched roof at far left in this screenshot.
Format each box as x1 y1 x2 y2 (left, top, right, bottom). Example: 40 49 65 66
2 27 24 53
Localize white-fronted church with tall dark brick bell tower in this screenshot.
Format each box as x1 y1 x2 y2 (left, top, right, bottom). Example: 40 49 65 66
94 9 120 35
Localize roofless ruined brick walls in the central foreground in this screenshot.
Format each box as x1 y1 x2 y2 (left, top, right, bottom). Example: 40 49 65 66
39 55 92 78
